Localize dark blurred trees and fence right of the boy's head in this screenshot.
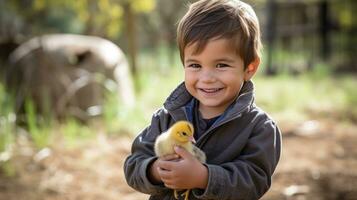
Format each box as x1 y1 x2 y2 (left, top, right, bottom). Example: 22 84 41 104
262 0 357 75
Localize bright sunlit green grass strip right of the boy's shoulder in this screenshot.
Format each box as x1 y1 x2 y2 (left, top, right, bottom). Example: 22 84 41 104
254 72 357 120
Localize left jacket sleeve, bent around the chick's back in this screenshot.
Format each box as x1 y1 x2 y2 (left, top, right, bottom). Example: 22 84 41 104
124 111 167 195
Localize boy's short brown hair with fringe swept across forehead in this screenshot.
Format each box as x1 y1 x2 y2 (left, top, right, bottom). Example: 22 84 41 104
177 0 262 68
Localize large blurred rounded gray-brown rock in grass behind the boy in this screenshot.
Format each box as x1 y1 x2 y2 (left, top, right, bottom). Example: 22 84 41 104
5 34 135 120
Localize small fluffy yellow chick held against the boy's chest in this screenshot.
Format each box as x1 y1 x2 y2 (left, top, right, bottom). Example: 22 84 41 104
154 121 206 200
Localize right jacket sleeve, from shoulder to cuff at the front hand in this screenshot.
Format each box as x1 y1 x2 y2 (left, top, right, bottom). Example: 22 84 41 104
193 120 281 200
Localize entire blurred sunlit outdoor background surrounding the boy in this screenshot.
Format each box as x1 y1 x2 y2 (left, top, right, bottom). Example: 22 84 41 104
0 0 357 200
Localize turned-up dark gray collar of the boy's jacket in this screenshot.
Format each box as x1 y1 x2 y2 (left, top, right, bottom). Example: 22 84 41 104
164 81 254 118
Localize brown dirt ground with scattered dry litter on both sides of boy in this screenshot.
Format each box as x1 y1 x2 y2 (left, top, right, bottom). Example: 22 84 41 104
0 119 357 200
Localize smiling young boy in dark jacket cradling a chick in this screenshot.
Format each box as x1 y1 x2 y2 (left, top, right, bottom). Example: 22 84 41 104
124 0 281 200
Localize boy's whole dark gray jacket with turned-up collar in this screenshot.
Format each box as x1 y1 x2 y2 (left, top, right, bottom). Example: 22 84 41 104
124 81 281 200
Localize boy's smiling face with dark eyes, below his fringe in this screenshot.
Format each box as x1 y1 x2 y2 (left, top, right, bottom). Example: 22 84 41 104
184 39 255 118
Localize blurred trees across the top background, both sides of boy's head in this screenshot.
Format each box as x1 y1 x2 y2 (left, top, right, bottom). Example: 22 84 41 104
0 0 357 75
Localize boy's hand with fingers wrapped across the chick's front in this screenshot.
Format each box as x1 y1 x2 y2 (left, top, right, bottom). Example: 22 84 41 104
157 146 208 189
